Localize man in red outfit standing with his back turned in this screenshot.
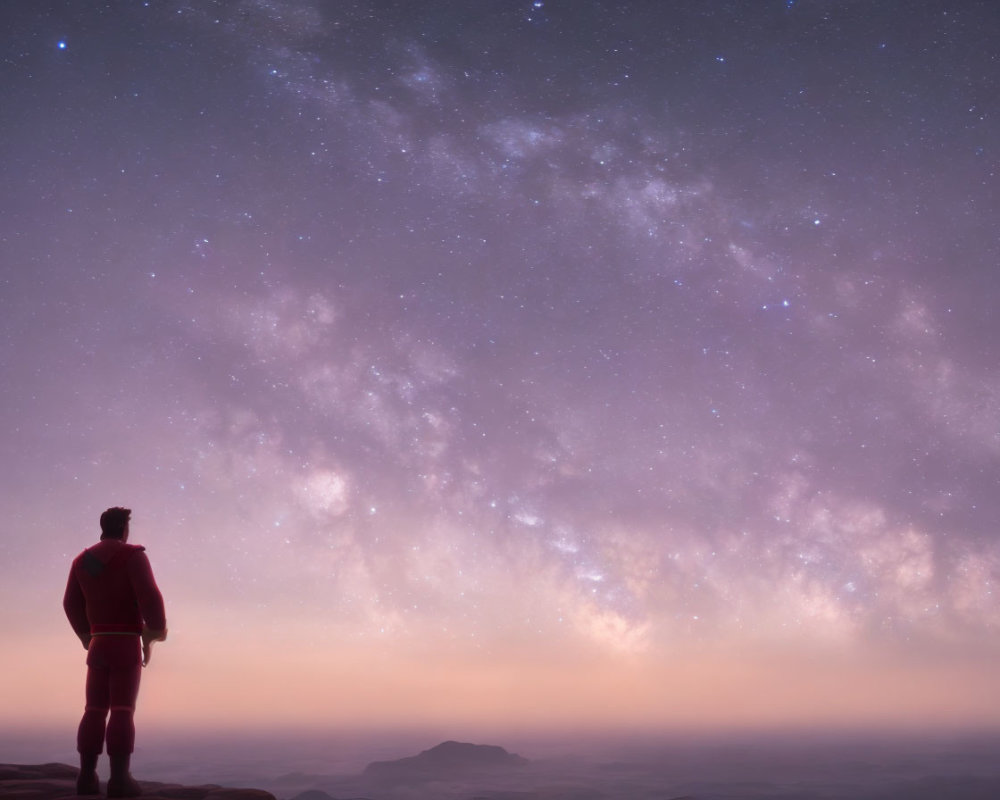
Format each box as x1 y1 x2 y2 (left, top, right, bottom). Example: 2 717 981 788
63 507 167 797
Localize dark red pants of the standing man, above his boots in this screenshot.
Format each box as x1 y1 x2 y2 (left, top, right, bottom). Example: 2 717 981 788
76 635 142 756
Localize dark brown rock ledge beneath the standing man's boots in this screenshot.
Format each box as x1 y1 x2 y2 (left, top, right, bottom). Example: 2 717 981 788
0 764 275 800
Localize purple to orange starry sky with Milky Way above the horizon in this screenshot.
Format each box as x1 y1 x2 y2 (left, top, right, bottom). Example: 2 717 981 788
0 0 1000 731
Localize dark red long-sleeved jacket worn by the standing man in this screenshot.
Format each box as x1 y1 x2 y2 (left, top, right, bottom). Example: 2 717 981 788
63 539 167 636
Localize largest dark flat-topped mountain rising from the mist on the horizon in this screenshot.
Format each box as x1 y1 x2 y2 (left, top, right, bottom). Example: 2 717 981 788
364 742 528 781
